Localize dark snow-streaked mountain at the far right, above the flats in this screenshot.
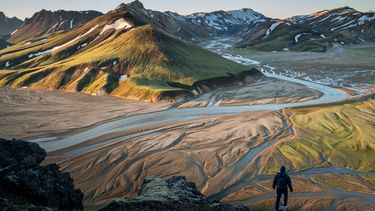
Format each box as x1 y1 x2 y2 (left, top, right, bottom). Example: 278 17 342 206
236 7 375 51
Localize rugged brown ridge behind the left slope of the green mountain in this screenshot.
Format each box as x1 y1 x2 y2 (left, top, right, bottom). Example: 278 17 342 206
8 10 102 43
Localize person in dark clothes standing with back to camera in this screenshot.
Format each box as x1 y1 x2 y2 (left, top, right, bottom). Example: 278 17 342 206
272 166 293 211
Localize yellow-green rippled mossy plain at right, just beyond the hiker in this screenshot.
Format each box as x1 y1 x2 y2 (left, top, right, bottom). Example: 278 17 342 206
263 100 375 173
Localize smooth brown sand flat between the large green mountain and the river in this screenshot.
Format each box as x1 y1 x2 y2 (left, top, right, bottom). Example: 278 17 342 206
0 87 169 139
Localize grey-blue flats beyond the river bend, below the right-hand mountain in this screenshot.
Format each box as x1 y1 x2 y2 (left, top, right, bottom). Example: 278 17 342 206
220 43 375 90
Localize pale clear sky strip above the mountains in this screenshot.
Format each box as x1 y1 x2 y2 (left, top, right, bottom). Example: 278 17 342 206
0 0 375 19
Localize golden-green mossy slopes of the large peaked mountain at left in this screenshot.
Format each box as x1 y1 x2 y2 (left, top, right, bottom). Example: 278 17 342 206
0 24 256 101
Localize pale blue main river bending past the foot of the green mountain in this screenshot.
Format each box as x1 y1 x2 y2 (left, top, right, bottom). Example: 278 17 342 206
31 49 348 152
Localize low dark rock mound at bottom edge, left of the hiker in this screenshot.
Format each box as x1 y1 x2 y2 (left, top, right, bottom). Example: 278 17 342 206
101 176 248 211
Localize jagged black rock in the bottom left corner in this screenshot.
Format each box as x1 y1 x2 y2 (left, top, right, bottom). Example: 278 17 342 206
0 139 83 210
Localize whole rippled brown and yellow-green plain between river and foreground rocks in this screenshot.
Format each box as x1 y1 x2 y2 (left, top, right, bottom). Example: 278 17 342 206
42 97 375 210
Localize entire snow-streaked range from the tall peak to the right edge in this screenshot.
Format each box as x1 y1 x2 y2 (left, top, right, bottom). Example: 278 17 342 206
107 2 375 51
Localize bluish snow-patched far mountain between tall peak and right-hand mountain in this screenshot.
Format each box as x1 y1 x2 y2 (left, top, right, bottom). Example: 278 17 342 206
110 1 268 42
